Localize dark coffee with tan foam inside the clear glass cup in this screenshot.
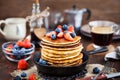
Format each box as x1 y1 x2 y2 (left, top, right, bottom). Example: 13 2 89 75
91 26 113 46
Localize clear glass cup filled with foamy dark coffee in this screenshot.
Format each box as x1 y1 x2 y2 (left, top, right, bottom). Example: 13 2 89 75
89 20 116 48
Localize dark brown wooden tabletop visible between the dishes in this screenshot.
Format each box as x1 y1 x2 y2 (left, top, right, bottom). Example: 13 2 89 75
0 36 120 80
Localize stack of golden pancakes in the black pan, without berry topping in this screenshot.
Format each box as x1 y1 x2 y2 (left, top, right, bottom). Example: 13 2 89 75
41 36 83 66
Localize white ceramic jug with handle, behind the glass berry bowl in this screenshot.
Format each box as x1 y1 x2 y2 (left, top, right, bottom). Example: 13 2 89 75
0 18 26 40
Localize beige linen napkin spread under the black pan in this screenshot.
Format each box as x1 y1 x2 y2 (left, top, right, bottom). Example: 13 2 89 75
10 64 116 80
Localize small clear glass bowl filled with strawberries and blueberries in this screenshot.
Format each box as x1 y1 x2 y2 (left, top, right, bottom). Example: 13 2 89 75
2 39 35 62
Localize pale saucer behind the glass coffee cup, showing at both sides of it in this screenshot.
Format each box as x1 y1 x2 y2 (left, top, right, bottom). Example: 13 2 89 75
80 24 120 40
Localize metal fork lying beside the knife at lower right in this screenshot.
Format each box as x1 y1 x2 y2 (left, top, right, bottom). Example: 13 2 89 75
92 61 113 80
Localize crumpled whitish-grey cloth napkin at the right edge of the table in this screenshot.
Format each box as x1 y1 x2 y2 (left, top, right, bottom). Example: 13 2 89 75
104 46 120 61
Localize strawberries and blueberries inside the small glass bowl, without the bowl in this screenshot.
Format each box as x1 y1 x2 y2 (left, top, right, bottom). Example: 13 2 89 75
4 39 32 60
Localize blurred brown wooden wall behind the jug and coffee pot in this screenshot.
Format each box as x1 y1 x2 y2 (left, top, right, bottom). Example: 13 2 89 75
0 0 120 24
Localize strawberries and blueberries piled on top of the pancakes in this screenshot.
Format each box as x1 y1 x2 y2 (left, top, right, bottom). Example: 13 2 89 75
46 25 76 41
